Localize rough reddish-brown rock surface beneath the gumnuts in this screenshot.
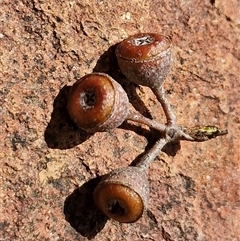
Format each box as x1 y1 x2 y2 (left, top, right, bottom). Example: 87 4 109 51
0 0 240 241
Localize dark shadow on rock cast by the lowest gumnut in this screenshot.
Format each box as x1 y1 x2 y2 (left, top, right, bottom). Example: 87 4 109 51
64 177 108 239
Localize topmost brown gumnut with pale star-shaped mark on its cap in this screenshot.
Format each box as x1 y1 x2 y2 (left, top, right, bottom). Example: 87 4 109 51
116 33 173 88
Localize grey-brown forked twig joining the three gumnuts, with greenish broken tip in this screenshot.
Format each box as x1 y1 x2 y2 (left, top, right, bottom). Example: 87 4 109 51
126 86 228 171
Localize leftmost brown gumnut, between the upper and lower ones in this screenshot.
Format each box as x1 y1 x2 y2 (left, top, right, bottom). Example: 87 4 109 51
68 73 129 132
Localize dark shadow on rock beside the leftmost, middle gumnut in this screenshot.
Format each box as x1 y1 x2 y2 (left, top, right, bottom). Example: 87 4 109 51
44 86 90 149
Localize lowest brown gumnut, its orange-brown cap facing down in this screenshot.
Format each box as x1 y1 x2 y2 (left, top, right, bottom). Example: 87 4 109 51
93 166 149 223
